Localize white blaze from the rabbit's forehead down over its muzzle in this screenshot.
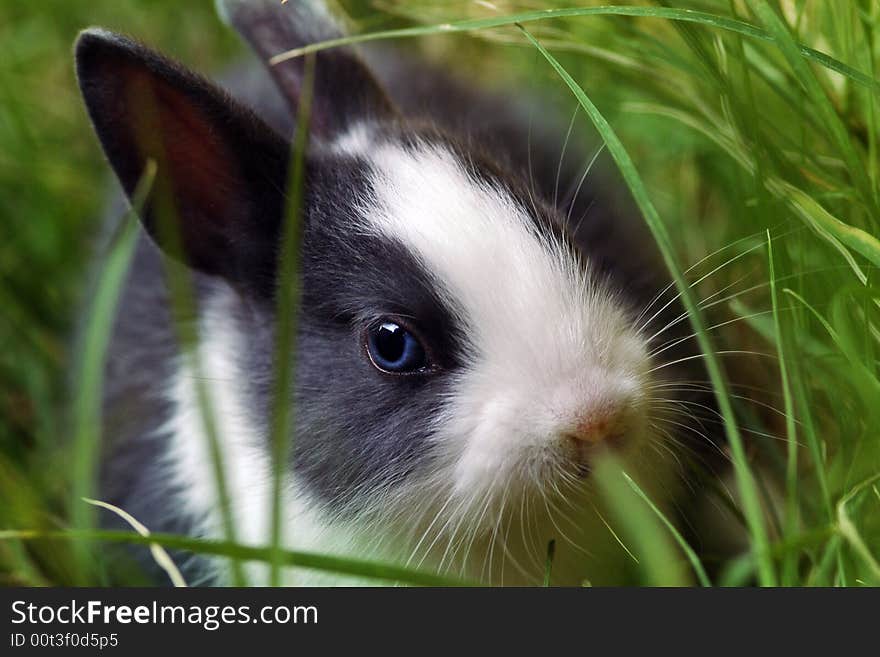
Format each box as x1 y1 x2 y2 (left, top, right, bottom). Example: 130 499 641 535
362 144 648 501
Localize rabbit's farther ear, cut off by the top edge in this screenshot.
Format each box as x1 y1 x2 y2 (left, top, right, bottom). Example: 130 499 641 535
217 0 395 140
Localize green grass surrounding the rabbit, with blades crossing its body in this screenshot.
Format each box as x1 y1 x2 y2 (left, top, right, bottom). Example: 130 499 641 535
0 0 880 586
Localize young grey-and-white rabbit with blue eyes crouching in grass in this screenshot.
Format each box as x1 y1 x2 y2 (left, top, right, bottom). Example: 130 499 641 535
75 0 712 585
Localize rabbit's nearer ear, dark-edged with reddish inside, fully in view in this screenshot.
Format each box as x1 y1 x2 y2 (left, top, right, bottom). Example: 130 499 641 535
76 30 289 288
